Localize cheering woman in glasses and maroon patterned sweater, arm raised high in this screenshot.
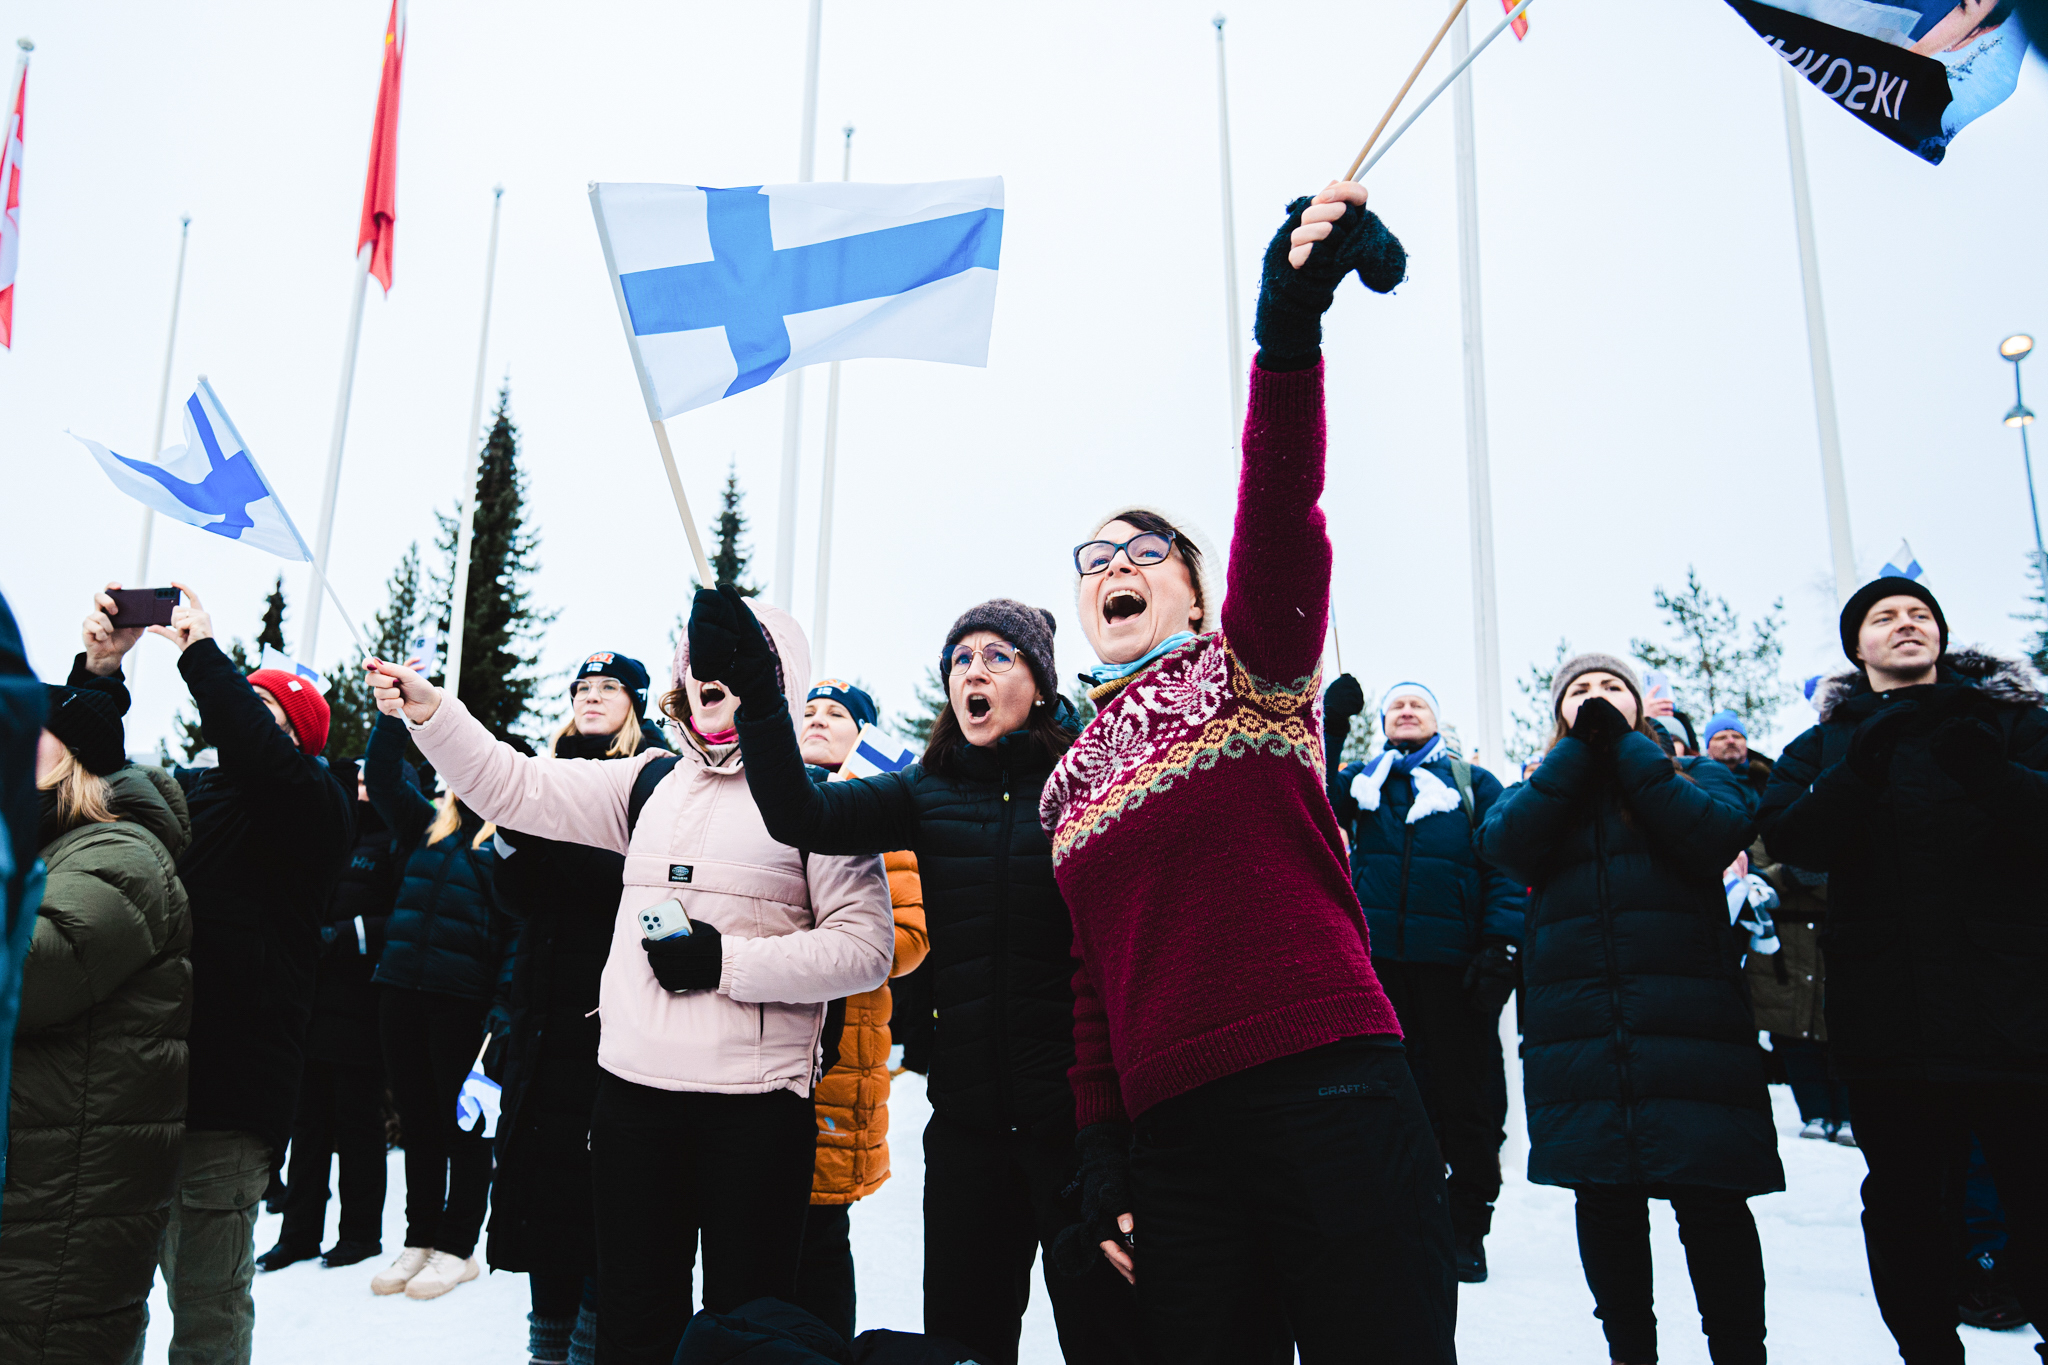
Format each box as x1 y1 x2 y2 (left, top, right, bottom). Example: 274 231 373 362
1038 182 1456 1365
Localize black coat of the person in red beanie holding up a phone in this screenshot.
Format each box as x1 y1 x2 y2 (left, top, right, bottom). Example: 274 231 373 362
142 639 356 1160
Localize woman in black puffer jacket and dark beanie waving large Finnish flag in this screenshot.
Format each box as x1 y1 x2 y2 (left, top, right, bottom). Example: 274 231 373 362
690 589 1139 1365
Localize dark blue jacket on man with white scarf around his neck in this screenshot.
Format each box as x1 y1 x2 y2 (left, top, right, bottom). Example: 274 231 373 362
1325 753 1528 966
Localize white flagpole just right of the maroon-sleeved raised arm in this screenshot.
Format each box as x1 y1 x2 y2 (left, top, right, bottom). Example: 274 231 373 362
1450 12 1503 763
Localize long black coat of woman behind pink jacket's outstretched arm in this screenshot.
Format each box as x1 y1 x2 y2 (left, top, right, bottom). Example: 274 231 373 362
487 724 670 1275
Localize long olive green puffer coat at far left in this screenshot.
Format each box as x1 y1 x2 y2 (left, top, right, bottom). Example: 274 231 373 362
0 765 193 1361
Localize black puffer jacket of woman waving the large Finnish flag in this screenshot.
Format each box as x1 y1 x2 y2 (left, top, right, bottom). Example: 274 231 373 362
737 702 1077 1142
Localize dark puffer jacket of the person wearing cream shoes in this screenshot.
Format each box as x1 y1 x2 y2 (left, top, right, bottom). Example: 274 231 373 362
362 716 512 1001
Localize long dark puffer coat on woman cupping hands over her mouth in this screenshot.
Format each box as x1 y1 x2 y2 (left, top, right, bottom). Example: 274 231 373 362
1479 733 1784 1195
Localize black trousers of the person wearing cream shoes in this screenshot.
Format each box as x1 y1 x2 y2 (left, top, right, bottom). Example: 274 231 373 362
377 986 492 1257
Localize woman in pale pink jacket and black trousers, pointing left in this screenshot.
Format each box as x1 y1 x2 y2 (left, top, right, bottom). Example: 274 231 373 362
369 608 895 1365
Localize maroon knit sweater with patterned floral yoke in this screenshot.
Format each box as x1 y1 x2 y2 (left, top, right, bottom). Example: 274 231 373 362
1038 364 1401 1126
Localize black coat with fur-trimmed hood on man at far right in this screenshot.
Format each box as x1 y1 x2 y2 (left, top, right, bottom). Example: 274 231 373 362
1761 651 2048 1085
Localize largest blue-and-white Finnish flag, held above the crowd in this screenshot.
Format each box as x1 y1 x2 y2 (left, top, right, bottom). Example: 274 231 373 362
590 176 1004 420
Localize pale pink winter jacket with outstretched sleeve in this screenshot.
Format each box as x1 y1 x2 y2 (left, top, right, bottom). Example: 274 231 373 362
412 606 895 1095
